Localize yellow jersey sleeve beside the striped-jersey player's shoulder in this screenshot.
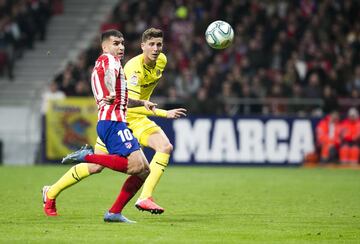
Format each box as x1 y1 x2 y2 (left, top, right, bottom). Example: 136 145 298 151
124 61 141 99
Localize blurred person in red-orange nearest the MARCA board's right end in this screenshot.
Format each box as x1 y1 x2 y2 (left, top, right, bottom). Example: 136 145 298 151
316 110 341 163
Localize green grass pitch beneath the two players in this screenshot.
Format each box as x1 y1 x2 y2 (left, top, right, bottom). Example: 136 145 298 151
0 166 360 243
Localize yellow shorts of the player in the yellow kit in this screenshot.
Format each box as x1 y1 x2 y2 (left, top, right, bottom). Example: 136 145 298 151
95 116 161 153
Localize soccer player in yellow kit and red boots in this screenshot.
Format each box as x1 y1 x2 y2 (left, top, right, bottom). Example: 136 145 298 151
94 28 186 214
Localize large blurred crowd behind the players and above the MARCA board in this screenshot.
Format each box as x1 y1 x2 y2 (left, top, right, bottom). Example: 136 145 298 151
51 0 360 115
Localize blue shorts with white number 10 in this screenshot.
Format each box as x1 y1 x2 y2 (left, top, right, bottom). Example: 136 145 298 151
96 120 140 157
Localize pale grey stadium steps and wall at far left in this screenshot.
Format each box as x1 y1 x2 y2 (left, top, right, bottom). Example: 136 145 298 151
0 0 116 164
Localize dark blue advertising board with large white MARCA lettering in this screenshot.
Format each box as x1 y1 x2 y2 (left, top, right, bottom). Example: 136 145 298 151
145 117 317 165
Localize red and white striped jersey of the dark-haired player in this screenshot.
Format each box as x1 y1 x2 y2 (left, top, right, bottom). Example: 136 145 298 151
91 53 128 122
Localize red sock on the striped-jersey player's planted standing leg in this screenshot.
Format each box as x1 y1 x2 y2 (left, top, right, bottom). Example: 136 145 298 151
109 175 144 213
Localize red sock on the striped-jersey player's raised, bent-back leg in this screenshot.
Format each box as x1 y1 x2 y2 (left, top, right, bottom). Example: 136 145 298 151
85 154 128 173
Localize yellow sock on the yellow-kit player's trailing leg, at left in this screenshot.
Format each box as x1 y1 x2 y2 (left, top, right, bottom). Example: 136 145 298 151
47 163 90 199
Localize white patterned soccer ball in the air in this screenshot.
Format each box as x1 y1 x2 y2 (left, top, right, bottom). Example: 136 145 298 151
205 20 234 49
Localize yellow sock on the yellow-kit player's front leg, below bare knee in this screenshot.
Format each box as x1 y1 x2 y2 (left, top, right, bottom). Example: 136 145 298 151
140 152 170 199
